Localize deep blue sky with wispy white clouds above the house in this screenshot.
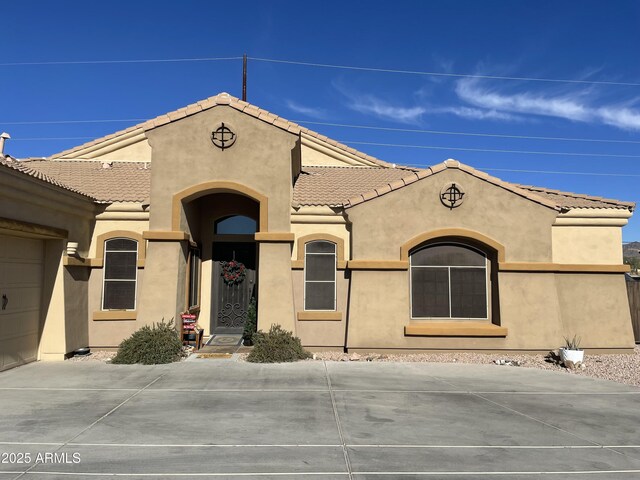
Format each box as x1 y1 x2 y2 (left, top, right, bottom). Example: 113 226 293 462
0 0 640 241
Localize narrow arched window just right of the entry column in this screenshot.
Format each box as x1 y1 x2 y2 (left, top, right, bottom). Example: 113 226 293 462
304 240 336 311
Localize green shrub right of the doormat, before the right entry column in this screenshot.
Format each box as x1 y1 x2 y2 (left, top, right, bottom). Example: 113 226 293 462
247 325 311 363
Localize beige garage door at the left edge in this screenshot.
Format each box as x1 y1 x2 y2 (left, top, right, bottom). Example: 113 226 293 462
0 234 44 371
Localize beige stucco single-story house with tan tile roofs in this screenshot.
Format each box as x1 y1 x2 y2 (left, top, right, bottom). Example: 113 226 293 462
0 93 634 370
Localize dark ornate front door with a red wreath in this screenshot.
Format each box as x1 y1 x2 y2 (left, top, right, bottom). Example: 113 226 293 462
211 242 257 335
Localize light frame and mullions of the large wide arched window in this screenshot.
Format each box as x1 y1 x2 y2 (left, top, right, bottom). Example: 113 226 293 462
408 240 491 322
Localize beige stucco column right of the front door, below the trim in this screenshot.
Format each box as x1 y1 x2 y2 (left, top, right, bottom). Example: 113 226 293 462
258 243 296 335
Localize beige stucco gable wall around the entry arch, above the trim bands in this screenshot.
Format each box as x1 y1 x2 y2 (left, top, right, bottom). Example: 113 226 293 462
147 106 298 232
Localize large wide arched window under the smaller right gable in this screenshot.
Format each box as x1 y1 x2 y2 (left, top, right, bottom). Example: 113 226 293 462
410 243 489 320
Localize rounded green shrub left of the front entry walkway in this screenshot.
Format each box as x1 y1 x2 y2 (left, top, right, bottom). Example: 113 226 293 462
111 319 182 365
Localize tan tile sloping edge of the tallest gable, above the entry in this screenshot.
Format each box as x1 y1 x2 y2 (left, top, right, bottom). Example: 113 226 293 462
50 92 391 167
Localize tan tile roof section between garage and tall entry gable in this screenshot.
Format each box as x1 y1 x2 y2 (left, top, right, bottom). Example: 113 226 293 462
20 160 151 203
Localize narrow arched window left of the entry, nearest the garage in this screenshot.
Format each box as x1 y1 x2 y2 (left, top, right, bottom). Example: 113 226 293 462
102 238 138 310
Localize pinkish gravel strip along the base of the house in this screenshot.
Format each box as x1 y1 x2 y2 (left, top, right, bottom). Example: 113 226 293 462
69 345 640 387
